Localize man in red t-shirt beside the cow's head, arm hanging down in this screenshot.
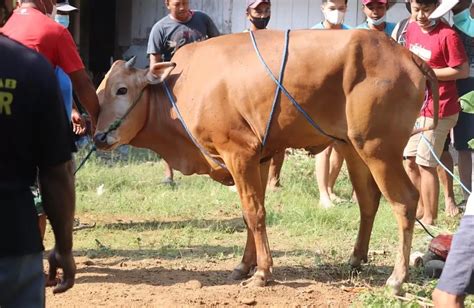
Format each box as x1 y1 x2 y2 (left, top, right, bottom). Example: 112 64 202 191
2 0 99 125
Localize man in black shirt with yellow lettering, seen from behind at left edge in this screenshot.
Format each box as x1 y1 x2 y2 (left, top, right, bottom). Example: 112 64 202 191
0 35 75 307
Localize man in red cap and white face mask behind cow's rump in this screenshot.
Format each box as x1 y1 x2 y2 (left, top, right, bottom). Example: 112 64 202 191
357 0 396 36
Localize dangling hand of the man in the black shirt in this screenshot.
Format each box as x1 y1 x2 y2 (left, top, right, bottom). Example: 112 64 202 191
46 247 76 294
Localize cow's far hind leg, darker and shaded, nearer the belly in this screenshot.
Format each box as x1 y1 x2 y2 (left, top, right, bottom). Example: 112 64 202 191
336 144 381 268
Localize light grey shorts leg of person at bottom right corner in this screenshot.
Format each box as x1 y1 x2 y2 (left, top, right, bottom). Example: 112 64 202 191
437 215 474 295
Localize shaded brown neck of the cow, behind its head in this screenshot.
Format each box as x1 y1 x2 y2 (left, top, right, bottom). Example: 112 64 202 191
130 85 211 174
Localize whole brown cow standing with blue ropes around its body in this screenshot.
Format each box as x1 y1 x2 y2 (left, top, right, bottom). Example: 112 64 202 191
95 30 438 290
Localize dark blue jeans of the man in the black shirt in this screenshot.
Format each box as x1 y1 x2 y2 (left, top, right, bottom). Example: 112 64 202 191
0 252 45 308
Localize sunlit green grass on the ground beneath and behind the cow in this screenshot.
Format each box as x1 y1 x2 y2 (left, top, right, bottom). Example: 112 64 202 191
56 149 474 307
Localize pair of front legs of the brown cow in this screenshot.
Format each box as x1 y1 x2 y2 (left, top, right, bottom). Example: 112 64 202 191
227 156 273 286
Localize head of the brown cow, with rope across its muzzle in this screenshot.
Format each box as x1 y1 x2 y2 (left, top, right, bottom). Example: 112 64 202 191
94 58 175 150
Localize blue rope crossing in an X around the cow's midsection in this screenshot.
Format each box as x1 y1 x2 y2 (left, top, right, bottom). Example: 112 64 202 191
249 30 346 143
